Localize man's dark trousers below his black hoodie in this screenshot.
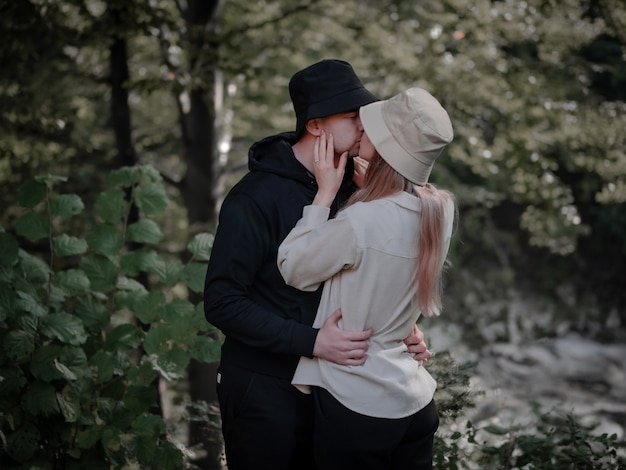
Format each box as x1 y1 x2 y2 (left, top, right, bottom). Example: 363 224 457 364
217 366 315 470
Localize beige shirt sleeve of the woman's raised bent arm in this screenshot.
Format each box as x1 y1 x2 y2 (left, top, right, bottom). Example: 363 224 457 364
278 205 358 291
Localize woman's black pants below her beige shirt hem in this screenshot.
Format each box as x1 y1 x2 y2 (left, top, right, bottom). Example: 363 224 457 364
313 387 439 470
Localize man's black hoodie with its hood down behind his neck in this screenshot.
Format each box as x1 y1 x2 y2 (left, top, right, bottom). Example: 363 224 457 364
204 133 354 379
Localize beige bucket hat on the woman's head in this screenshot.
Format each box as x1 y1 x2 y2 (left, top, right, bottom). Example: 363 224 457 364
359 87 454 186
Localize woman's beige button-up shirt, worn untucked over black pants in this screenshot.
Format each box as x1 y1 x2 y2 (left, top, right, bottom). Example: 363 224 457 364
278 191 454 418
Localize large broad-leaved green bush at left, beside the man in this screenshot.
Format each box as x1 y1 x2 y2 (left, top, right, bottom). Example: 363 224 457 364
0 166 219 469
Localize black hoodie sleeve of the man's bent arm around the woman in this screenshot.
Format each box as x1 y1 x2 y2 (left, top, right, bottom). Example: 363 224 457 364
204 193 318 356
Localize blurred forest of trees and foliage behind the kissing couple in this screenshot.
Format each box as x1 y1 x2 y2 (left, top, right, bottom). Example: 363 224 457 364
0 0 626 468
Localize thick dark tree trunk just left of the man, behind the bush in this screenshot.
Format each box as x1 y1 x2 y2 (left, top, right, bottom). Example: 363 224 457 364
181 0 224 470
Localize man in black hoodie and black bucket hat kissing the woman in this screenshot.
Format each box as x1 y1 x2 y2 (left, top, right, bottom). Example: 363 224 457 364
204 60 430 470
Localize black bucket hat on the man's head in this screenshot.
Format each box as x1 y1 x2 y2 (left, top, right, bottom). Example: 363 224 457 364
289 59 378 138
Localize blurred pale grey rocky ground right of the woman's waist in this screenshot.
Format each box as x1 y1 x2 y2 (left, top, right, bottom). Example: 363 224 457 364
429 325 626 439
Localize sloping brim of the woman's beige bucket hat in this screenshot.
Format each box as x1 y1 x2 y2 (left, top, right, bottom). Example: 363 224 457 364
359 101 434 186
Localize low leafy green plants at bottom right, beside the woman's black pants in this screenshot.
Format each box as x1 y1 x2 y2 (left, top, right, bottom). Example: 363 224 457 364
428 360 626 470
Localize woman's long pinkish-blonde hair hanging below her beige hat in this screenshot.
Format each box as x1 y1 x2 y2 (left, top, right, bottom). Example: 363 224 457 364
344 154 456 316
